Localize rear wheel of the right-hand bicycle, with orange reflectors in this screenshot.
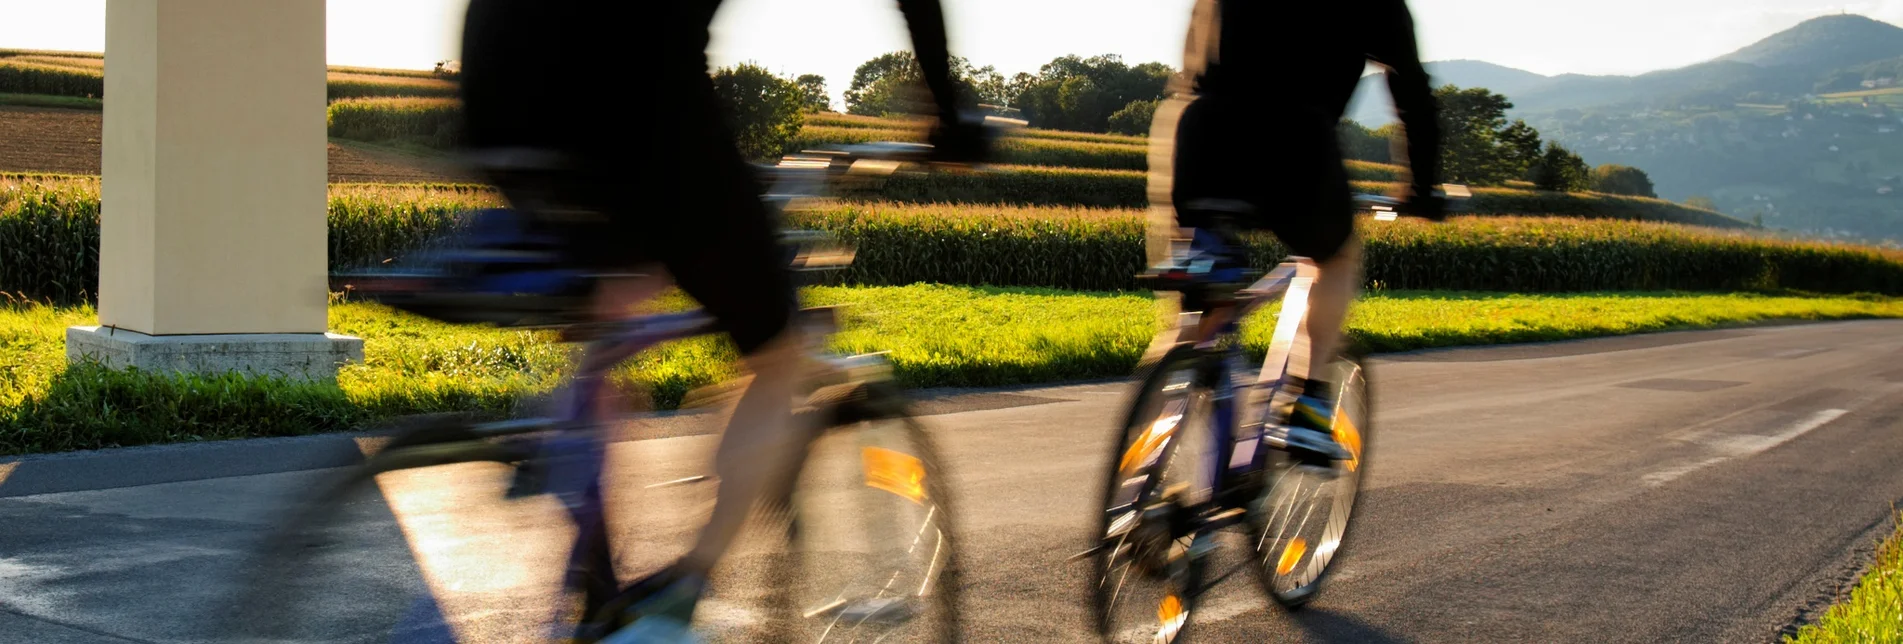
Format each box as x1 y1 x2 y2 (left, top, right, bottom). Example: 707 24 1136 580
1089 347 1210 642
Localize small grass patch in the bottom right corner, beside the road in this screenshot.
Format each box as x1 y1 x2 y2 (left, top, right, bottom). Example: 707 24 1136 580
1785 514 1903 644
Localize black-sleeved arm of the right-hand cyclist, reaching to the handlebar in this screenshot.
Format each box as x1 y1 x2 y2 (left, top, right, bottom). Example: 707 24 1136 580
1368 0 1441 194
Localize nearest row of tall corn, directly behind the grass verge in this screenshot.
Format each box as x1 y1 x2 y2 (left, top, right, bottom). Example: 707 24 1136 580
0 178 1903 301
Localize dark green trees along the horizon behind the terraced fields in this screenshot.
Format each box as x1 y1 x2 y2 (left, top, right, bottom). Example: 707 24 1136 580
714 51 1658 196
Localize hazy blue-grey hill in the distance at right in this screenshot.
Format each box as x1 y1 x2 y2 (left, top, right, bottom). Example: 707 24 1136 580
1349 15 1903 240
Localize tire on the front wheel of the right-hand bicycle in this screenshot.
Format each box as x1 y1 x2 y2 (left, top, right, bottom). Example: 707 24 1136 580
1248 347 1374 612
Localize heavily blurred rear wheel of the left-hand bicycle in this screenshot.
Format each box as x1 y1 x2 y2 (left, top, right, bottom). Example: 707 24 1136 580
207 417 611 644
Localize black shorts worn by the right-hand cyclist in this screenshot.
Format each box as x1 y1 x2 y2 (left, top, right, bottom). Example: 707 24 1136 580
1170 95 1355 261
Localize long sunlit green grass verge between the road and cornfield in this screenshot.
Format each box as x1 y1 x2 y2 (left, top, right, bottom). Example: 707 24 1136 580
0 286 1903 453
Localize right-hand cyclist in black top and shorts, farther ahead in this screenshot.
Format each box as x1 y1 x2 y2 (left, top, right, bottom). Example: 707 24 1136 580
1149 0 1446 462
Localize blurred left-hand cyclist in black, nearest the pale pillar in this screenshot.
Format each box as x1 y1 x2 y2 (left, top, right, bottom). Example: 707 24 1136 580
461 0 984 636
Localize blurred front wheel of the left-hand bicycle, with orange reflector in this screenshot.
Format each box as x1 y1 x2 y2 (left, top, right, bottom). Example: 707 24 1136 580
753 383 963 642
